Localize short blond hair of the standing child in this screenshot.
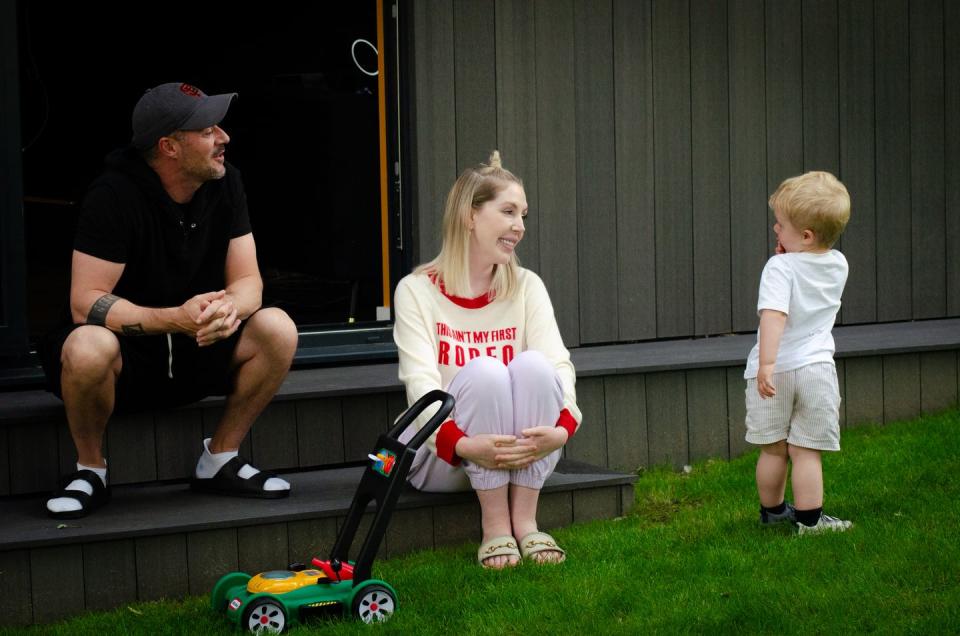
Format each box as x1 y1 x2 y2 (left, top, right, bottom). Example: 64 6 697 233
769 171 850 247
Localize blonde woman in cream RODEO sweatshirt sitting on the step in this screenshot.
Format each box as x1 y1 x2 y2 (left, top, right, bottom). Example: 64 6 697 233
394 151 581 569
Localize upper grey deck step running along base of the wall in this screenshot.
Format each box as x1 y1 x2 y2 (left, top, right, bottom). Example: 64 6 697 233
0 318 960 498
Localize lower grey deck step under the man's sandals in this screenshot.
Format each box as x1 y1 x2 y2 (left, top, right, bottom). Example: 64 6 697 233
0 460 635 625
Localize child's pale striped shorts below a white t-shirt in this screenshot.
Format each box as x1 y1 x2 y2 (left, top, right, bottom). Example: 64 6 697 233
746 362 840 451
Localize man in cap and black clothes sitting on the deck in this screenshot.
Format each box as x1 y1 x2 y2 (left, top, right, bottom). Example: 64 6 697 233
41 82 297 518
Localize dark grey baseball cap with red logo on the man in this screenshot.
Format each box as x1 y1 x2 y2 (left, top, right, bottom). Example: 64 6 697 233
131 82 237 150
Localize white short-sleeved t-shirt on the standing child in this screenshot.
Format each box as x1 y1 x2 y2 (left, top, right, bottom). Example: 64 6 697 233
743 250 848 379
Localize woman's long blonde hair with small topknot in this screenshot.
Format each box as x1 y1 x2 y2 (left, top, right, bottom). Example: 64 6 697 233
414 150 523 299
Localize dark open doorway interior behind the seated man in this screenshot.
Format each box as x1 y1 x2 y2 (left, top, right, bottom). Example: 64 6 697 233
19 0 383 341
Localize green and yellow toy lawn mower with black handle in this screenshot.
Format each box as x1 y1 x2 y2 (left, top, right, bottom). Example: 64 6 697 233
210 391 454 634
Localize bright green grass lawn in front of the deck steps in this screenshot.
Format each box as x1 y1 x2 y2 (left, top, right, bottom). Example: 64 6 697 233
9 411 960 635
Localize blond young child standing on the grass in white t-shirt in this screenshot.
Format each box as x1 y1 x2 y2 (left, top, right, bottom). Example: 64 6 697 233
743 172 852 534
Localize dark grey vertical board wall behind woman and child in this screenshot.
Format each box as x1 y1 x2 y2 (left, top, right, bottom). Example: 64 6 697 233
409 0 960 346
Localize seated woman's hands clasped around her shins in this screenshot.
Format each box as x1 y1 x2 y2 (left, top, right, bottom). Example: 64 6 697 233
454 426 567 470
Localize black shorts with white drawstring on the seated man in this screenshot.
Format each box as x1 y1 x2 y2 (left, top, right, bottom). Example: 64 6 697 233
38 321 247 413
